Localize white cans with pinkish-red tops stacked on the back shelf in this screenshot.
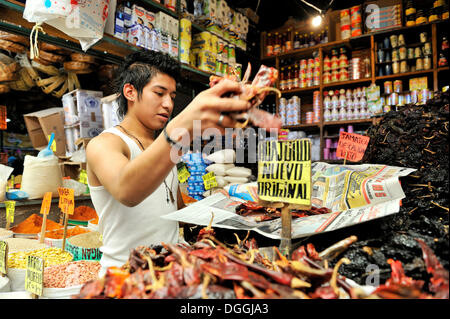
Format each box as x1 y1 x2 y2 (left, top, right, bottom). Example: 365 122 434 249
323 87 372 122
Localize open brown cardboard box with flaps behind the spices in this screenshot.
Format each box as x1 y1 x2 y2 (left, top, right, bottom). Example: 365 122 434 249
23 107 66 156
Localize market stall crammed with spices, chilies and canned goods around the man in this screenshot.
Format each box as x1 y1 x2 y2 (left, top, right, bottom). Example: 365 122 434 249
0 0 450 299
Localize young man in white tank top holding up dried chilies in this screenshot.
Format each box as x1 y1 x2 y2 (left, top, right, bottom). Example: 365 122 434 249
86 51 250 276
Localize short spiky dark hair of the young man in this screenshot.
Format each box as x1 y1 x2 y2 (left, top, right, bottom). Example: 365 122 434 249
114 50 181 118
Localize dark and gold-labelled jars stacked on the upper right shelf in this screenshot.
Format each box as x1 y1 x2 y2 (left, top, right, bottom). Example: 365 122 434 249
377 31 433 76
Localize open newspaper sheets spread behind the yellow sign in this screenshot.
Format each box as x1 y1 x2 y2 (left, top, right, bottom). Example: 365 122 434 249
163 162 415 240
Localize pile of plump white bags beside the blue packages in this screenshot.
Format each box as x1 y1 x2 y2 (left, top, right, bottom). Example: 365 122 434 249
206 149 252 188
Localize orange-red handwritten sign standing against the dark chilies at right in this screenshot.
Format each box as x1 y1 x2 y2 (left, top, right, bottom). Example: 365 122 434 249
336 132 370 162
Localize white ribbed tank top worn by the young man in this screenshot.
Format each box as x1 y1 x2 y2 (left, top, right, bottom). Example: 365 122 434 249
88 127 179 277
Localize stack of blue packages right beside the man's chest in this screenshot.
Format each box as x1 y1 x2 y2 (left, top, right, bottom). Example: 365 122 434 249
183 153 207 200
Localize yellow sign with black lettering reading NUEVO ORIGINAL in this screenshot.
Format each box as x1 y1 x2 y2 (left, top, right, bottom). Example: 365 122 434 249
258 139 311 206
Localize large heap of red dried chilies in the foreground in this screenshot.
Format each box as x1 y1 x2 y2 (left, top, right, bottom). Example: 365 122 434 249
74 220 448 299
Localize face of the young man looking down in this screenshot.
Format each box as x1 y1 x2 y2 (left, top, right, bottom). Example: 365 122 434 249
134 73 176 130
